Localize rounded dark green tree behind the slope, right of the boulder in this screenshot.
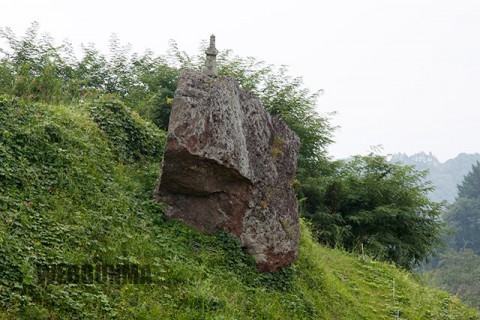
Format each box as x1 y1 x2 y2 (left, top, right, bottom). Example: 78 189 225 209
305 154 442 268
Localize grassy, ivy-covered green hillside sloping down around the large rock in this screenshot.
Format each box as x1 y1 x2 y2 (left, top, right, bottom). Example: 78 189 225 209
0 96 479 319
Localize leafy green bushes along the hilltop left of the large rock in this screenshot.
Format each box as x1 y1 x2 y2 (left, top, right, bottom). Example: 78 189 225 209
0 23 179 129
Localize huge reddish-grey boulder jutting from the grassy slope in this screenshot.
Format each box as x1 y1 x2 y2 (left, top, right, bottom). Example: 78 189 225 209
155 70 300 272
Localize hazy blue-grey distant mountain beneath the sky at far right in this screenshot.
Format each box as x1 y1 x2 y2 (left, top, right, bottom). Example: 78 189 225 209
390 152 480 203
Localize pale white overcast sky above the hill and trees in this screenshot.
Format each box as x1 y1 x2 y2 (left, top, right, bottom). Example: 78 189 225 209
0 0 480 161
